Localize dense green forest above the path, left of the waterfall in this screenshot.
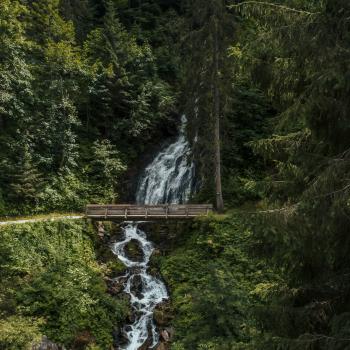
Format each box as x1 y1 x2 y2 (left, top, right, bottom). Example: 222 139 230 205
0 0 175 215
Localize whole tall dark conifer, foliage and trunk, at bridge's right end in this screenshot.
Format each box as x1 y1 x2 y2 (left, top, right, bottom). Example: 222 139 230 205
185 0 233 211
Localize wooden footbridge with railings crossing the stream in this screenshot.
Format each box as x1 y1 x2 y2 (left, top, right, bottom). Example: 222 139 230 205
85 204 213 221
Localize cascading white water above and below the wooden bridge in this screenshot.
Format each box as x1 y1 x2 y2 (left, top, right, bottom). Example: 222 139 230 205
113 116 194 350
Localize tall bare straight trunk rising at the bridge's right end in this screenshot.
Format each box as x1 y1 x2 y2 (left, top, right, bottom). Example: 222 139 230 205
214 18 224 213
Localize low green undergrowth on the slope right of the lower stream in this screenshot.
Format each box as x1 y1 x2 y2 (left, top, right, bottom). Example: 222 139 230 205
160 215 278 350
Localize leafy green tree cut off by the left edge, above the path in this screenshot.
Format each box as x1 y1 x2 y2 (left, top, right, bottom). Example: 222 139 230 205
0 0 33 211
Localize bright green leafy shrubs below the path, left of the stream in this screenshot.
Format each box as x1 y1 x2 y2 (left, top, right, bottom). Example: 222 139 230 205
0 221 128 349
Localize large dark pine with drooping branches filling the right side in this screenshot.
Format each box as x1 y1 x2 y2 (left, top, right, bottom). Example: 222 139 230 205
236 0 350 350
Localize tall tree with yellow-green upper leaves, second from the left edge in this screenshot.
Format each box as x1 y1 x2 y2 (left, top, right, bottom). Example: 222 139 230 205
29 0 86 172
